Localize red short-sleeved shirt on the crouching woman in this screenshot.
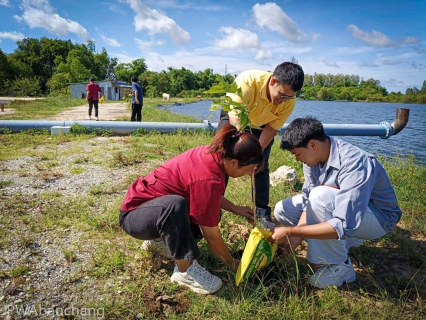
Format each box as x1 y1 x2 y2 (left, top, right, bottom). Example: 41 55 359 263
120 146 225 227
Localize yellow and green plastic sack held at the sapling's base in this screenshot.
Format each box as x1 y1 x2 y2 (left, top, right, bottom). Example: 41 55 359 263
235 228 278 286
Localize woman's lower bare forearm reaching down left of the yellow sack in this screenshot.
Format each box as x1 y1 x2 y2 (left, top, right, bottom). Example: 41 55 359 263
200 226 239 271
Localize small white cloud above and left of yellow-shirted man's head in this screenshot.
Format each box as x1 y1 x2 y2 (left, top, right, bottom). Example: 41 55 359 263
214 27 259 49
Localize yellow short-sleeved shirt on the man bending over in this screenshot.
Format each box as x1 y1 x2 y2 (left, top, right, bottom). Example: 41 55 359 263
226 70 296 130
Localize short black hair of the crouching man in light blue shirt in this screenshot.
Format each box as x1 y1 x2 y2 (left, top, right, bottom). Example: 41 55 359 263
280 117 327 151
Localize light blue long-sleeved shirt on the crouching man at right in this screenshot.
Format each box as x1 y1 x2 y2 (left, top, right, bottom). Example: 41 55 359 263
302 137 402 239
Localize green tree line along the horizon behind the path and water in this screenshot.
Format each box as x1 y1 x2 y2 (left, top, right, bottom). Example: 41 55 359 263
0 37 426 103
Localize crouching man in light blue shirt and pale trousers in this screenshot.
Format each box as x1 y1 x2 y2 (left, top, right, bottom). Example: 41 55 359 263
269 117 402 288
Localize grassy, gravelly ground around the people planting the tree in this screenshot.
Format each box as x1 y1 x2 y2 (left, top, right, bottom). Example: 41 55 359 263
0 99 426 319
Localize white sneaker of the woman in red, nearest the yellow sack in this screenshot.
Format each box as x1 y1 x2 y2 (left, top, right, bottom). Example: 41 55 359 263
170 260 222 294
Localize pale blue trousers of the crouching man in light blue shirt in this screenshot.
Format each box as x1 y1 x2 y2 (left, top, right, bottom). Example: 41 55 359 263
274 186 386 265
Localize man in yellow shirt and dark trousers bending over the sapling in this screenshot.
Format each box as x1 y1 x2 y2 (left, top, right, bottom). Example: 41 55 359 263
218 62 305 226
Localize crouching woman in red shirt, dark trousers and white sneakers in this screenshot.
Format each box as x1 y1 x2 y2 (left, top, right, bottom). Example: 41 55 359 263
120 124 264 294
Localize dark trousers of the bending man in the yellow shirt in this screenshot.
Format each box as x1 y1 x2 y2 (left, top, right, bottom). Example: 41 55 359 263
217 110 274 218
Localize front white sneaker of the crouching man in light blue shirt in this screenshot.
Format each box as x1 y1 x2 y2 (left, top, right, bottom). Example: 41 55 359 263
311 258 356 289
